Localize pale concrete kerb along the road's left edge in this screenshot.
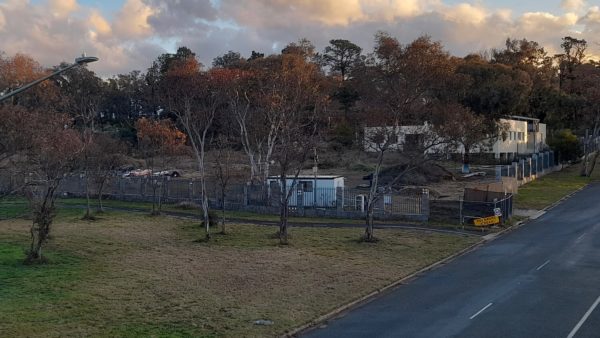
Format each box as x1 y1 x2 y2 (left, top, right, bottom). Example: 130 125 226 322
281 183 590 338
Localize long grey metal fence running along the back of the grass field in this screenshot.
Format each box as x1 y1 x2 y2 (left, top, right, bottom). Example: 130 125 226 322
0 175 513 225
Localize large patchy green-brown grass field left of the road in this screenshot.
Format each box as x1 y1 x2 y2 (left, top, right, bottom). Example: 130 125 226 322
0 209 477 337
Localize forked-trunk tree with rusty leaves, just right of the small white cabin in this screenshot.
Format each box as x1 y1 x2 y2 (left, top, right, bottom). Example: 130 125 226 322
359 32 453 241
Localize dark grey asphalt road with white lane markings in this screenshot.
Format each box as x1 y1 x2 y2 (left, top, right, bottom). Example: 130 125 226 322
304 185 600 338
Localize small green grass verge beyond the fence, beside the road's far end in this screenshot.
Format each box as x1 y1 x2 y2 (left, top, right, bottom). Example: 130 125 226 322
515 165 600 209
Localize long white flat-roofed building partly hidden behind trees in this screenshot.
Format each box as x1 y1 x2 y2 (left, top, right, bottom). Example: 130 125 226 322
364 116 547 158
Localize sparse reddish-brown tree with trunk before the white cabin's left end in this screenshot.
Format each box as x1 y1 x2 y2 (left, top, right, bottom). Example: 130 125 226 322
260 54 327 244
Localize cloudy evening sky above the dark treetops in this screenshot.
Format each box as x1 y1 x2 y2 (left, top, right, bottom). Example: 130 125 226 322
0 0 600 77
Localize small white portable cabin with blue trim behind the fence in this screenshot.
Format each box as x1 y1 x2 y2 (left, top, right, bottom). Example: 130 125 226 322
267 175 344 208
